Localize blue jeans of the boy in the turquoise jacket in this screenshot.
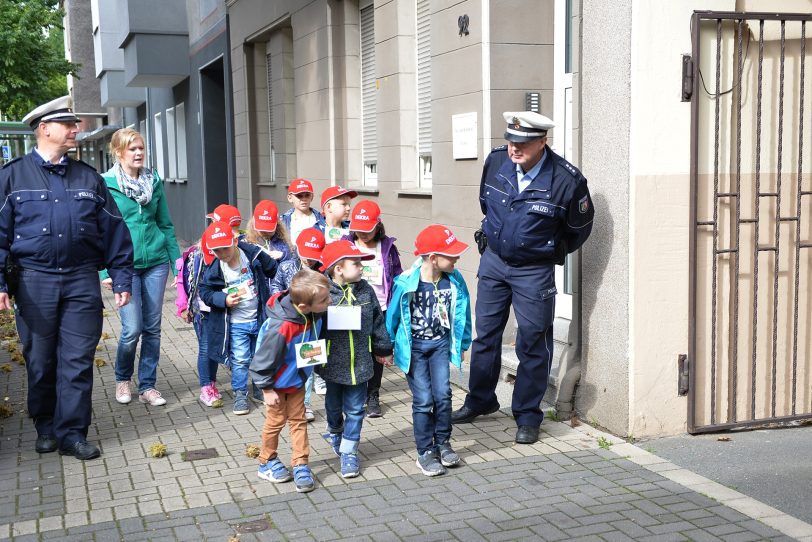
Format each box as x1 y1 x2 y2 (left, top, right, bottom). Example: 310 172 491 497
406 336 451 454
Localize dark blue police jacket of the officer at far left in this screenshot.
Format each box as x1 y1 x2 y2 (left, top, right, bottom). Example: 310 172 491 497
0 155 133 293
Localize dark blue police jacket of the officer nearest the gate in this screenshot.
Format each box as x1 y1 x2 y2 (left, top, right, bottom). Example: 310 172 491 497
479 145 594 266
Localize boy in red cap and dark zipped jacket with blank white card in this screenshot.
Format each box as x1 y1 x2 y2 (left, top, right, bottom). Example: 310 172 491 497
316 240 392 478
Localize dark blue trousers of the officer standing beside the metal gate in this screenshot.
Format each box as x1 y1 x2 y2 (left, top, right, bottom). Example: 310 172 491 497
465 249 555 427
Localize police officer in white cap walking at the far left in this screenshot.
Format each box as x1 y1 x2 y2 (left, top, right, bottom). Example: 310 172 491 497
0 96 133 460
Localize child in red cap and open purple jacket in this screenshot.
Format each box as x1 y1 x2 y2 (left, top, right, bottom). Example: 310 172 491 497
344 199 403 418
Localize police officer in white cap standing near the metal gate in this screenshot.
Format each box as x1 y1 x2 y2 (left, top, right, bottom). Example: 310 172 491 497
452 111 594 444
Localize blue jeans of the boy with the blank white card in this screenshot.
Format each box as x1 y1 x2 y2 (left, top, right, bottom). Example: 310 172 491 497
324 381 367 454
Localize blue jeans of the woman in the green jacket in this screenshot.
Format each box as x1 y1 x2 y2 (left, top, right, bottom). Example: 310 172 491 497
116 263 169 393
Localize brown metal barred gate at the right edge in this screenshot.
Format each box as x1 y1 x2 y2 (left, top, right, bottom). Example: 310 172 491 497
692 12 812 433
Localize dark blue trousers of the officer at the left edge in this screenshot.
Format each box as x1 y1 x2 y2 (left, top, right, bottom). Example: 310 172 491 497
15 269 103 449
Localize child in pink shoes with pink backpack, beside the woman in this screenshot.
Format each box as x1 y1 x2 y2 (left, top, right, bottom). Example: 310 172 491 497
175 238 222 407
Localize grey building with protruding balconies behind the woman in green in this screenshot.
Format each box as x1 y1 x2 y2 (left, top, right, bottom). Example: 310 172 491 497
65 0 235 241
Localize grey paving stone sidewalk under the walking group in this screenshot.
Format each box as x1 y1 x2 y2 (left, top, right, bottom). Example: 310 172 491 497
0 288 812 542
